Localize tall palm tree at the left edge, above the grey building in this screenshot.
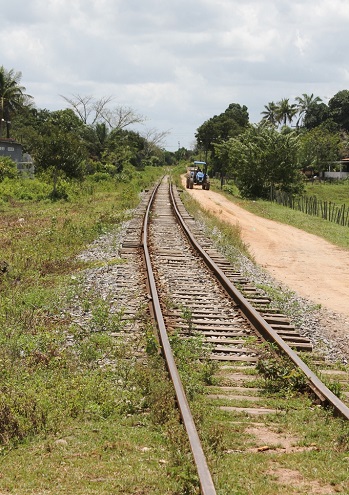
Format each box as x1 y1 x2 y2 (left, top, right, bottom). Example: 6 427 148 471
0 65 32 138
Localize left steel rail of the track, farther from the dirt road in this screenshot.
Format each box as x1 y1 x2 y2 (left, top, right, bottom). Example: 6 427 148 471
142 182 216 495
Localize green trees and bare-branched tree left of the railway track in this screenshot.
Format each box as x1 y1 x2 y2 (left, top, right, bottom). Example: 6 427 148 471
0 66 182 195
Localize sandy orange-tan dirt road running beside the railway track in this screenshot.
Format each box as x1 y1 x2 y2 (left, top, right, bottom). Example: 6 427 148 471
181 180 349 317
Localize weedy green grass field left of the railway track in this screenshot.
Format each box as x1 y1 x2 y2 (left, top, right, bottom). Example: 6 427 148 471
0 168 204 494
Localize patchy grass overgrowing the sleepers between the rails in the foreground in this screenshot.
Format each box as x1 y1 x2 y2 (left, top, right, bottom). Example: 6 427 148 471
185 360 349 495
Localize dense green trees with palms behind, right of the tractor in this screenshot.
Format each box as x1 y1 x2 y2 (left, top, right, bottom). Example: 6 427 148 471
196 90 349 198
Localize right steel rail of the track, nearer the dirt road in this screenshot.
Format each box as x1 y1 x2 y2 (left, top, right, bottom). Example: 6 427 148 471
170 183 349 420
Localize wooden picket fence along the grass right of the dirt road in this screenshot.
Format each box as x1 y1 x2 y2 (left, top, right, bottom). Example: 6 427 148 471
270 190 349 227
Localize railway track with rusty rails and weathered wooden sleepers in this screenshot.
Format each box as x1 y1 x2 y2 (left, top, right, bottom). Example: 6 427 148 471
119 178 349 495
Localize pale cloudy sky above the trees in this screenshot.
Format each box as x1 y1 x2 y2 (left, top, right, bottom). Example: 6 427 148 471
0 0 349 151
